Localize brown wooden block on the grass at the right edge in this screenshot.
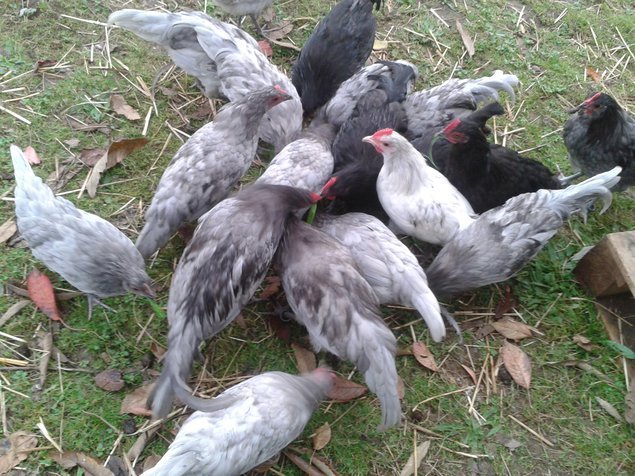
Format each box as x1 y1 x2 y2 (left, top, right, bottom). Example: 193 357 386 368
574 231 635 297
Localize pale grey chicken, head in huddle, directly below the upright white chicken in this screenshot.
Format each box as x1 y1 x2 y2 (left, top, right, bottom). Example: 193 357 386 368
313 213 445 342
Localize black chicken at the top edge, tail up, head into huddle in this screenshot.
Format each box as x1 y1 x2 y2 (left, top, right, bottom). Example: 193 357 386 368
291 0 381 115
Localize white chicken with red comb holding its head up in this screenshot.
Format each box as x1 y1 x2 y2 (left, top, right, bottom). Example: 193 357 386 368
363 129 475 245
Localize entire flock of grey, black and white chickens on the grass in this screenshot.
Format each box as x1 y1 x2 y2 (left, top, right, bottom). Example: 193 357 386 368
11 0 635 475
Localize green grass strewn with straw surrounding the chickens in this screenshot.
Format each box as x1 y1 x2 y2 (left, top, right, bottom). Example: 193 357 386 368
0 0 635 475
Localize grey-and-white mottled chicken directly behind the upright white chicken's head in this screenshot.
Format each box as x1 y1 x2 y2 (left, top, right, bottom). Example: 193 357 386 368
404 71 518 157
